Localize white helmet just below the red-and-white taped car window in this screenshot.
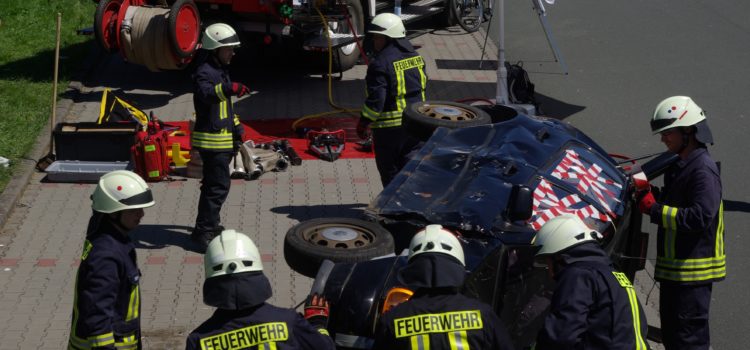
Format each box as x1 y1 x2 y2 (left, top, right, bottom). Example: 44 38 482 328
534 214 601 256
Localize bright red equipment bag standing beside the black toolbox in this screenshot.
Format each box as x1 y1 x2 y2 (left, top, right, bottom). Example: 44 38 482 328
131 130 169 182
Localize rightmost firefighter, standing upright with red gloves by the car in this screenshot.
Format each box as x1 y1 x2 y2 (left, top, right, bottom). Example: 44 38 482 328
640 96 726 350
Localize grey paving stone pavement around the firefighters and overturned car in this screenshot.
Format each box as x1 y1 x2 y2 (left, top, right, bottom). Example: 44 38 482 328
0 22 656 350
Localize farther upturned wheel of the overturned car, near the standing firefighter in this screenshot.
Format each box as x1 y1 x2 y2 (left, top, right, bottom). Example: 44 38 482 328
402 101 492 141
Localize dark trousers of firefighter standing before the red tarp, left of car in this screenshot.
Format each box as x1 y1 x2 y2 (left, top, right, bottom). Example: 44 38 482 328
195 150 232 230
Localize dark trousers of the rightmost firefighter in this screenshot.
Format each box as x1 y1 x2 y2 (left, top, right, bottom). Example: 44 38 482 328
659 282 713 350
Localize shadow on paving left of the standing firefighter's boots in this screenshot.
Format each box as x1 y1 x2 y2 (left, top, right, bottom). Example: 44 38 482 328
129 225 196 252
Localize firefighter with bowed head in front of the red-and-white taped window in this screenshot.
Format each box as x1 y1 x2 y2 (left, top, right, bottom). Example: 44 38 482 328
534 214 648 350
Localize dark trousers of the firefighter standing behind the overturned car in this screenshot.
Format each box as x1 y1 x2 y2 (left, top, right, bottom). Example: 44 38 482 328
372 126 421 188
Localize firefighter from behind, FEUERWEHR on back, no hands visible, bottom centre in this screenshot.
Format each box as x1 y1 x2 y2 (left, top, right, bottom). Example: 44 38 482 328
374 225 513 350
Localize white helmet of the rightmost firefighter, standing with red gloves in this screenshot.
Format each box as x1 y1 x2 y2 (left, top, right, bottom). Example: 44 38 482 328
651 96 706 134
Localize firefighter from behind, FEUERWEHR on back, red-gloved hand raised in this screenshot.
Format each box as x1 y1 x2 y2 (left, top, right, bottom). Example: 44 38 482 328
185 230 335 350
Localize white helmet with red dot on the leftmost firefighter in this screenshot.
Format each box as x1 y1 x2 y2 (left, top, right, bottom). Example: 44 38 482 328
91 170 155 214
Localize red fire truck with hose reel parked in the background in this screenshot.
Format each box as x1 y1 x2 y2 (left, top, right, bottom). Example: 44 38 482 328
94 0 476 71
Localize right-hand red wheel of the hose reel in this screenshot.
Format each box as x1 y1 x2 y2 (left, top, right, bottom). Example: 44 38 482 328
167 0 201 58
